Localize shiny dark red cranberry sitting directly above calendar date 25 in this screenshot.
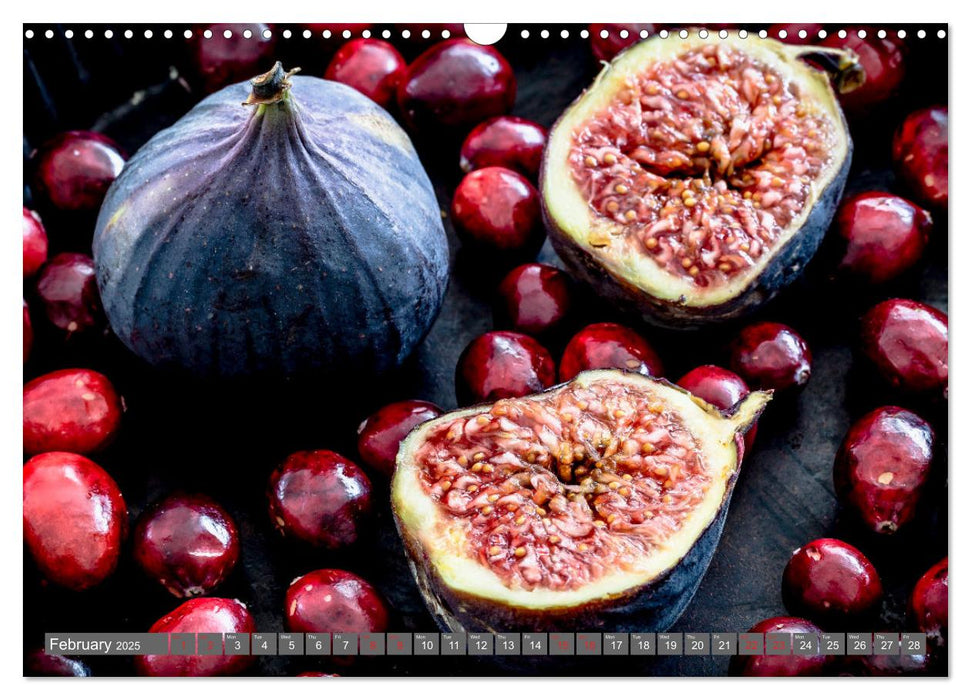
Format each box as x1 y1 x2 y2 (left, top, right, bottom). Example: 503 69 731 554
782 538 883 624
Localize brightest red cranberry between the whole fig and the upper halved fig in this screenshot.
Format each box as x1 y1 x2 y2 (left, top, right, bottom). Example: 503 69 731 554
452 167 545 255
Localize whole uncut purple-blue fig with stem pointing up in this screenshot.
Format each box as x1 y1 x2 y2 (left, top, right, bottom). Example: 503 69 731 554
94 72 449 383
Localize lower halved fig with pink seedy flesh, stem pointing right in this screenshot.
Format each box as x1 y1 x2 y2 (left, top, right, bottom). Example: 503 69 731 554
391 370 771 631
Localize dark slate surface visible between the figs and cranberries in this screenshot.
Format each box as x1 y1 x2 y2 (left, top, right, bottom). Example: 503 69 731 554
24 25 948 676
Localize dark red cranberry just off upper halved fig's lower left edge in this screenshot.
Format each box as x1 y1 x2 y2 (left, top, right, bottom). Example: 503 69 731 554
496 263 573 336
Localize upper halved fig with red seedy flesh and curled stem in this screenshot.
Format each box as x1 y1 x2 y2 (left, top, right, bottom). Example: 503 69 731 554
540 32 860 326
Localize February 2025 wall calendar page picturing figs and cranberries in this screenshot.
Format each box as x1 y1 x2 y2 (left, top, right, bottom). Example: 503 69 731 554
20 20 950 678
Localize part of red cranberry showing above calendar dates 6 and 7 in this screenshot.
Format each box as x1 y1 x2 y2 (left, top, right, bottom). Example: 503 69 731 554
285 569 388 634
